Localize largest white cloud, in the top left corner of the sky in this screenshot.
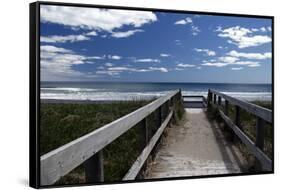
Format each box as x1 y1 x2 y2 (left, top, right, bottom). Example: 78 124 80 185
40 5 157 32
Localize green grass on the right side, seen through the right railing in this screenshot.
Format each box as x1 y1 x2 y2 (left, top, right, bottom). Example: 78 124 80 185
208 101 273 170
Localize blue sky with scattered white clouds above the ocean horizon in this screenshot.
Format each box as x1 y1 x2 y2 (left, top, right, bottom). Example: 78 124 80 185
40 5 272 83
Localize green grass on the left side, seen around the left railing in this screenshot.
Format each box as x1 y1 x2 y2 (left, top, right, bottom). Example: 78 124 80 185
40 96 183 184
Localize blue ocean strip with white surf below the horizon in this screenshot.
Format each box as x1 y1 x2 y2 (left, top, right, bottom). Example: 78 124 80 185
40 82 272 101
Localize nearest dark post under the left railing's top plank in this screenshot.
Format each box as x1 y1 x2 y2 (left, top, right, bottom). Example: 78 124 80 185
83 150 104 183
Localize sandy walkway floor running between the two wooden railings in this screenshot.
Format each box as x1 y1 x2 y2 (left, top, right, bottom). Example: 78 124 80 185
145 108 245 179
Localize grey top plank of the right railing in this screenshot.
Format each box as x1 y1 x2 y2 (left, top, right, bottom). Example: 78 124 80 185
210 90 272 123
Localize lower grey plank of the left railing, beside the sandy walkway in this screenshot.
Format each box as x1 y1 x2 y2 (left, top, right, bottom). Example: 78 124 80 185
123 111 173 181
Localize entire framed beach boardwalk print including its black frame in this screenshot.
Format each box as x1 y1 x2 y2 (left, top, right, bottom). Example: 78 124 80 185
30 2 274 188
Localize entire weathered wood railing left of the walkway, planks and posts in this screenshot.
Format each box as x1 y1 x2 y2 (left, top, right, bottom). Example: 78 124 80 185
40 90 181 185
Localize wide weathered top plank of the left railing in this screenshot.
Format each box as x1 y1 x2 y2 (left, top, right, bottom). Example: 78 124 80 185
40 90 179 185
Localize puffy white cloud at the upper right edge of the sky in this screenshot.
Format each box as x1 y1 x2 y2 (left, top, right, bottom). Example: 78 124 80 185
216 26 271 48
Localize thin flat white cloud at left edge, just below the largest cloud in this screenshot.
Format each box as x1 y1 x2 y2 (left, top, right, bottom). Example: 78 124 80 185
40 35 90 43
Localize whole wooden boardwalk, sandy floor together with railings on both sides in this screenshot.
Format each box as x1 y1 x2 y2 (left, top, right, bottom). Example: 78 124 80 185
40 89 273 186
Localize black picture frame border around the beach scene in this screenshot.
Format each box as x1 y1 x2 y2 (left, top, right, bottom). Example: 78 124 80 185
29 1 274 188
